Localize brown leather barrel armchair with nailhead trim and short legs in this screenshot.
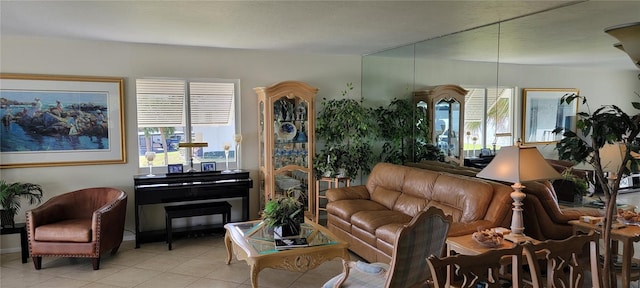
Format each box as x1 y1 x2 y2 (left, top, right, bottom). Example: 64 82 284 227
27 187 127 270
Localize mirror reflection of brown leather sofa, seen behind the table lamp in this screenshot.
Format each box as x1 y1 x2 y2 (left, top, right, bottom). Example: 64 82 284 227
406 159 601 240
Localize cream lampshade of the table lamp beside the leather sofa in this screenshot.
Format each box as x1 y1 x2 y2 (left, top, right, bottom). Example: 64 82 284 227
476 145 560 183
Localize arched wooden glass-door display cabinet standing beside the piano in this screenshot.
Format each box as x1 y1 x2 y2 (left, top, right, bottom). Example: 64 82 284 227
254 81 318 214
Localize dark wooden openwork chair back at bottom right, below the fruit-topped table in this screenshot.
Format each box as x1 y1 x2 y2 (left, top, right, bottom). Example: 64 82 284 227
524 232 602 288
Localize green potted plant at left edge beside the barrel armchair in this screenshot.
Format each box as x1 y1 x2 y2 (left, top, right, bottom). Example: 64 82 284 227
0 180 42 227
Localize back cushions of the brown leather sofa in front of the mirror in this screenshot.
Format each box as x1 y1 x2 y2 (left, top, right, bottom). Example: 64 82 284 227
366 163 493 222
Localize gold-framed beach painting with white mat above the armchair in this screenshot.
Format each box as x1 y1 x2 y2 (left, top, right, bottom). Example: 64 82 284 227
0 74 126 168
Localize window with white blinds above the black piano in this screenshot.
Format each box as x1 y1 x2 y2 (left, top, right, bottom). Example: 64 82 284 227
136 79 240 170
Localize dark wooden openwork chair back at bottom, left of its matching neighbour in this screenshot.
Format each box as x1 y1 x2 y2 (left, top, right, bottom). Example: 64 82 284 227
427 245 523 288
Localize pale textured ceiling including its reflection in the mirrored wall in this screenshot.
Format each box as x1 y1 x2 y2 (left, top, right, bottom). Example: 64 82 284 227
0 0 640 70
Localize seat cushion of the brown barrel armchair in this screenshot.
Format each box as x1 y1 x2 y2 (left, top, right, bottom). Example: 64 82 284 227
33 218 91 243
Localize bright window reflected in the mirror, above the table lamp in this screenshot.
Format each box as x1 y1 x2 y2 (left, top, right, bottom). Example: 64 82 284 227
464 87 515 157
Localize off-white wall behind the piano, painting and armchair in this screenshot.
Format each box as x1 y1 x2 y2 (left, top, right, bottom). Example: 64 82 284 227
0 35 361 252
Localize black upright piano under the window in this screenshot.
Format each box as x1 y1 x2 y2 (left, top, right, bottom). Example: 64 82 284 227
133 171 253 248
